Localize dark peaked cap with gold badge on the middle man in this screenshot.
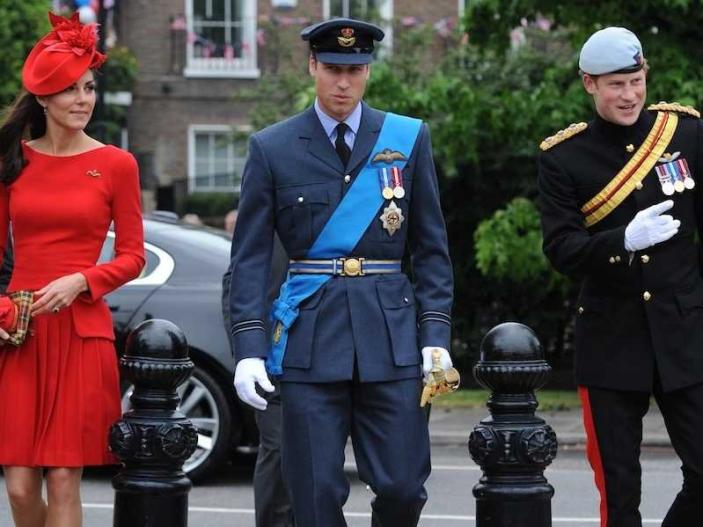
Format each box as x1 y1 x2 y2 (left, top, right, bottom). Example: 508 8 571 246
300 18 385 64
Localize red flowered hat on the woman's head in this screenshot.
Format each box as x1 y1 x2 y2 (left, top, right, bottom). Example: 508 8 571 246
22 13 107 95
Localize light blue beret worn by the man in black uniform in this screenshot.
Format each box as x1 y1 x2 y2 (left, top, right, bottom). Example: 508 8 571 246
579 27 644 75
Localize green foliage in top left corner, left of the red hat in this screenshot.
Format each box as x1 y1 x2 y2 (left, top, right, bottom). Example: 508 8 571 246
0 0 51 107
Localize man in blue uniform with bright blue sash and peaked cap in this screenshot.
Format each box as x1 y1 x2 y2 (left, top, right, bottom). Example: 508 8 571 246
230 19 453 527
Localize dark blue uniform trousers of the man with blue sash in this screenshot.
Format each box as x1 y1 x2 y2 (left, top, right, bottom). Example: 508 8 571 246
281 378 430 527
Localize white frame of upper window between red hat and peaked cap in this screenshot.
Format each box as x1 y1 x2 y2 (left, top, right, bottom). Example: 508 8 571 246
183 0 261 79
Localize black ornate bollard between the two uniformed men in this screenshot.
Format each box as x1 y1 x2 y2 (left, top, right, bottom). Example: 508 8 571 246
469 322 557 527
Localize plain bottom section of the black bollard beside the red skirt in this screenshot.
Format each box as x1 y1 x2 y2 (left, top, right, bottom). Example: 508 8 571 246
112 474 191 527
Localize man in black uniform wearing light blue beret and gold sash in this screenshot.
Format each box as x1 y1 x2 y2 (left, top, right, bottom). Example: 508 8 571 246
539 27 703 527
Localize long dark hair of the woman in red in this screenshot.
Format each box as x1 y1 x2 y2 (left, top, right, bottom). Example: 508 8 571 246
0 91 46 185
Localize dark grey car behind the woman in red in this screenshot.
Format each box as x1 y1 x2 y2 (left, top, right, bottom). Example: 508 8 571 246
101 213 258 480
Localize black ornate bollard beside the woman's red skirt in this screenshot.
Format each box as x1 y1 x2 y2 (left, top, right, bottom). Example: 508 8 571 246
110 319 198 527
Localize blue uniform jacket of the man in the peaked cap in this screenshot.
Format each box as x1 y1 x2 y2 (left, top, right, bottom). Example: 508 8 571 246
230 103 453 382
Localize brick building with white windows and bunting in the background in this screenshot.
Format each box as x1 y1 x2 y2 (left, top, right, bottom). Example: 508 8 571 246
118 0 465 210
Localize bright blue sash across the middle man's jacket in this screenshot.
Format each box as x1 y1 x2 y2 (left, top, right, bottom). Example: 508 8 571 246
266 113 422 375
